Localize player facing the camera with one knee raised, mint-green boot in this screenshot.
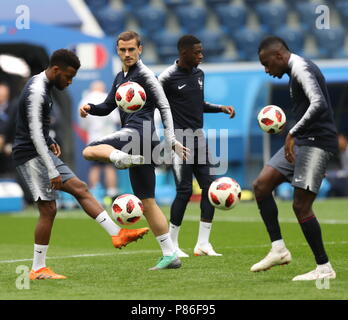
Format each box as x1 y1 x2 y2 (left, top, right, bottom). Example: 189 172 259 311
80 31 189 270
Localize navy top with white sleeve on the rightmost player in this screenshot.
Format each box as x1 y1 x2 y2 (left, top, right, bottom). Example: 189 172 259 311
288 54 338 153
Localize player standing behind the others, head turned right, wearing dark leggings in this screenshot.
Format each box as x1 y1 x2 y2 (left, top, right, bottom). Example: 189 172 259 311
159 35 235 257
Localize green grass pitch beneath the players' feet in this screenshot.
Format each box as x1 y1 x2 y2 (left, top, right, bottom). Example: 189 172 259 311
0 199 348 300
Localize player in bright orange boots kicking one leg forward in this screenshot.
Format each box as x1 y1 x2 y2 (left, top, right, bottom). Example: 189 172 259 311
13 49 149 280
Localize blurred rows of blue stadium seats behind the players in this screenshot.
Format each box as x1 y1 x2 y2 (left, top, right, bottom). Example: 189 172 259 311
85 0 348 62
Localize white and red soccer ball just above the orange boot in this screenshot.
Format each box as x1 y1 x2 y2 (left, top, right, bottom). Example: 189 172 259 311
112 194 144 225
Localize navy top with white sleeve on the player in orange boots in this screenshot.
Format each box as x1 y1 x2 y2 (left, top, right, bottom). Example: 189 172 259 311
12 71 59 179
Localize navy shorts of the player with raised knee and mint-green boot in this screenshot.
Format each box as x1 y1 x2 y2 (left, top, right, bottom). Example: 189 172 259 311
89 128 158 200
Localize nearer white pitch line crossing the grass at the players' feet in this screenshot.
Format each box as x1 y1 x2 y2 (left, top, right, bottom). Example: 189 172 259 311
0 241 348 263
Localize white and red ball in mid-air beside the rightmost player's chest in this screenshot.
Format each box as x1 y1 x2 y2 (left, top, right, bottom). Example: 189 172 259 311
257 105 286 134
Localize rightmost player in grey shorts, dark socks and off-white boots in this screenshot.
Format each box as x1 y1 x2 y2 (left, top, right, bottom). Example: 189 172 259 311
251 37 338 281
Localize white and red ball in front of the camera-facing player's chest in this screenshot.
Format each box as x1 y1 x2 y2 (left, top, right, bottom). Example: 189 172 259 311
115 81 146 113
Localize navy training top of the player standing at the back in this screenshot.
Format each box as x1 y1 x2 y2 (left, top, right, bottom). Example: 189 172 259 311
158 62 221 130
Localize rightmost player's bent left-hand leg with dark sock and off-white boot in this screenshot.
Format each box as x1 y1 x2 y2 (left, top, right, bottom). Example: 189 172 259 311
250 165 291 272
